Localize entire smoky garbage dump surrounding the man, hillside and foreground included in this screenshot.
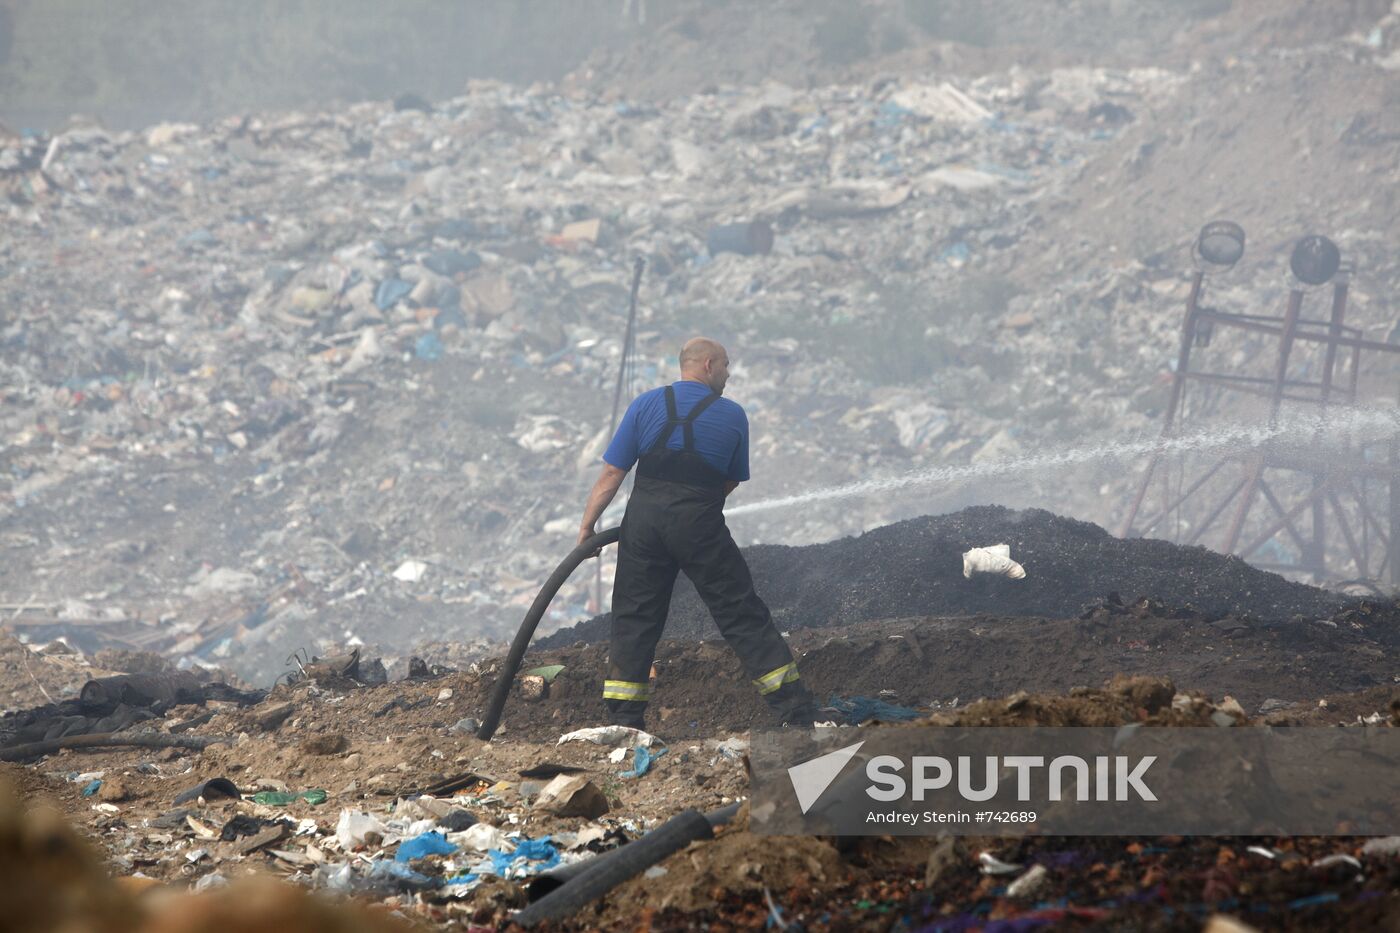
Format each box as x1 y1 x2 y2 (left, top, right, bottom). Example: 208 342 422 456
0 0 1400 933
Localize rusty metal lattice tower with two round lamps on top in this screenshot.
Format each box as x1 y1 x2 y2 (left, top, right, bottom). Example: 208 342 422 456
1121 221 1400 583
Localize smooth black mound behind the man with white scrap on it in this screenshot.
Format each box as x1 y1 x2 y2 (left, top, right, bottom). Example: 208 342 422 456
539 506 1347 647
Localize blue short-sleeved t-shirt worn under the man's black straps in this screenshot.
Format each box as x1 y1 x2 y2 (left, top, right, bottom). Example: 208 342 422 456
603 380 749 483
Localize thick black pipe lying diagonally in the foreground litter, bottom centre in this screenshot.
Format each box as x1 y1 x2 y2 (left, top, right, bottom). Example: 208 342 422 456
511 804 738 926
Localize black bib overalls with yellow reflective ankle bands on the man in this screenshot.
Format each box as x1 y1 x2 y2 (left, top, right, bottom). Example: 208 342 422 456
603 385 816 728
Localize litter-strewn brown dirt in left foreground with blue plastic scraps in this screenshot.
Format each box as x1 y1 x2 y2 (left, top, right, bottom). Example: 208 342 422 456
0 669 767 920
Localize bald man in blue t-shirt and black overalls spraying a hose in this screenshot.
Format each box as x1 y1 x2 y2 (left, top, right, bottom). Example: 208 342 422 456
578 338 816 728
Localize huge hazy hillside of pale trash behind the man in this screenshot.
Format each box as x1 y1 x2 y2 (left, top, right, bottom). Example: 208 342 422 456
0 5 1400 684
